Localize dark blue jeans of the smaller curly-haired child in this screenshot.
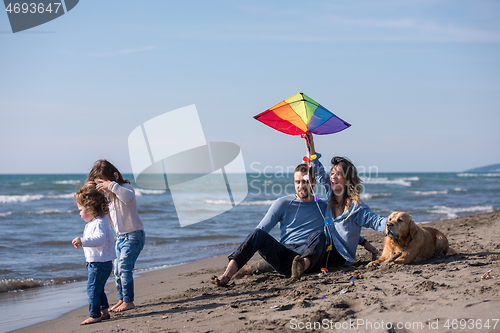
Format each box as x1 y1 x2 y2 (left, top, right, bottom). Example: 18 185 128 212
86 261 113 318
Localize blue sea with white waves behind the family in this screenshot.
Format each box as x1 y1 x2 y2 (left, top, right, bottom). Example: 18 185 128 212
0 172 500 332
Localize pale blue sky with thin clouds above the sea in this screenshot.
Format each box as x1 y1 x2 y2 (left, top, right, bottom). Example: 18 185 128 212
0 0 500 174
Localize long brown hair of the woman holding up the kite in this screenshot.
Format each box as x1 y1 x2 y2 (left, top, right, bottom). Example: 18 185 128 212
328 156 363 212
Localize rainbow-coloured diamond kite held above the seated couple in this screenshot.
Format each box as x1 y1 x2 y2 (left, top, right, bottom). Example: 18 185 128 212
254 93 351 135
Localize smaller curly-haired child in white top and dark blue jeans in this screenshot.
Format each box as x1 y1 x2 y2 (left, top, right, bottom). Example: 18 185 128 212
71 186 116 325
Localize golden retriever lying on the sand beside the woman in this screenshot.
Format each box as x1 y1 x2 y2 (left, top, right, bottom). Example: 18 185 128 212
368 212 457 266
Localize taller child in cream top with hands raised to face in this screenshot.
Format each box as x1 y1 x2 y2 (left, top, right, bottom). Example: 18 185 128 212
87 160 146 312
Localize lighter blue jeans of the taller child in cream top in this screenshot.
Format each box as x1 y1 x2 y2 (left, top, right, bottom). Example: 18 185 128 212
115 230 146 302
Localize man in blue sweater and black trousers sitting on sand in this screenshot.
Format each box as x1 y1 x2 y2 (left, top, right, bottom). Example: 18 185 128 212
212 164 327 286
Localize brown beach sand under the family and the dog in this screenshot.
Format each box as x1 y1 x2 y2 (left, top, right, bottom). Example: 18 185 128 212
15 211 500 333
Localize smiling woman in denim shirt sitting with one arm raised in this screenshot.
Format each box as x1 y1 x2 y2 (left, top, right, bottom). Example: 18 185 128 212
307 133 387 267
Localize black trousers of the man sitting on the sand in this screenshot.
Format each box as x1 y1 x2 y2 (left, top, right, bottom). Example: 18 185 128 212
228 229 326 275
